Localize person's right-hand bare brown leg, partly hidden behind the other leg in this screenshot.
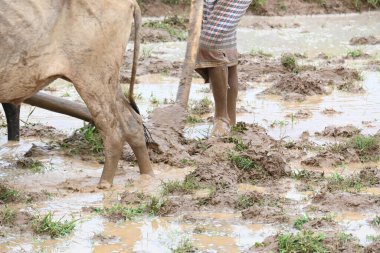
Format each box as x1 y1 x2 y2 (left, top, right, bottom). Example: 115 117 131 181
227 65 239 125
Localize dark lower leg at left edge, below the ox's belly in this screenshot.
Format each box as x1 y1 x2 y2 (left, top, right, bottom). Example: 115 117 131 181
2 103 21 141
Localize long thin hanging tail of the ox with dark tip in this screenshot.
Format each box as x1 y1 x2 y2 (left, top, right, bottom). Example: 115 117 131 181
128 2 142 114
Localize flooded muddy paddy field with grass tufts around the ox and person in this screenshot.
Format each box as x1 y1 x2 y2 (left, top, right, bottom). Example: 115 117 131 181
0 12 380 253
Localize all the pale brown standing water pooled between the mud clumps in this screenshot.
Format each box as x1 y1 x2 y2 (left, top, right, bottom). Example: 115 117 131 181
0 12 380 253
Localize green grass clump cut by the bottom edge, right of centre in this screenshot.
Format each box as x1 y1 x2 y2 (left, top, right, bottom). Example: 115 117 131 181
277 231 328 253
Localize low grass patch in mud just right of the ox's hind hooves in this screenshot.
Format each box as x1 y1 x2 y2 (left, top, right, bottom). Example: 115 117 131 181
161 175 201 196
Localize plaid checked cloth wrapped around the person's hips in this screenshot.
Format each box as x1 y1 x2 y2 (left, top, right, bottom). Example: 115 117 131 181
200 0 252 49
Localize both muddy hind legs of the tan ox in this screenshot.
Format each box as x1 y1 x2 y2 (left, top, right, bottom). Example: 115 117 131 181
74 78 153 188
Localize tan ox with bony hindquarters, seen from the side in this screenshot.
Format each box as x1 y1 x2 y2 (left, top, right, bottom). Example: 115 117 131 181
0 0 153 187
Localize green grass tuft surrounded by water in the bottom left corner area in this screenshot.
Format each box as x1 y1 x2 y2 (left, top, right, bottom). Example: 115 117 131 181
32 212 77 238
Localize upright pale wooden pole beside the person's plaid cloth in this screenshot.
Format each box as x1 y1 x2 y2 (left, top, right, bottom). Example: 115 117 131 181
176 0 203 108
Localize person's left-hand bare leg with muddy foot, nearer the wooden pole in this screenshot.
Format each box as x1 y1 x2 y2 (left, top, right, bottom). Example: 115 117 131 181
209 66 230 136
